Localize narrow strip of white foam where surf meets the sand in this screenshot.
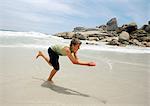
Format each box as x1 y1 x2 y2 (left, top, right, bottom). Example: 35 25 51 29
0 44 150 54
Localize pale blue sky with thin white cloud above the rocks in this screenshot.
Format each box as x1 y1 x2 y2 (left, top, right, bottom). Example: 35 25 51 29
0 0 150 34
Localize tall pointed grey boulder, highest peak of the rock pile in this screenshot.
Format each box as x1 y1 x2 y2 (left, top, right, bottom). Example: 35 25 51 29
106 18 118 31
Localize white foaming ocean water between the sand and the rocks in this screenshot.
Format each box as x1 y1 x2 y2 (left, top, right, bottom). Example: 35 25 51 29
0 31 150 53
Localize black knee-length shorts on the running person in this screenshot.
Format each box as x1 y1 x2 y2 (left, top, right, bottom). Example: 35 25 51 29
48 47 59 71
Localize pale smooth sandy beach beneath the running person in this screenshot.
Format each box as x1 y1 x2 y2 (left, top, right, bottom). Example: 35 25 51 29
0 47 150 106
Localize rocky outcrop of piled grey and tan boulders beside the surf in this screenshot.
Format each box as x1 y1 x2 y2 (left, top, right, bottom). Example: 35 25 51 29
55 18 150 47
